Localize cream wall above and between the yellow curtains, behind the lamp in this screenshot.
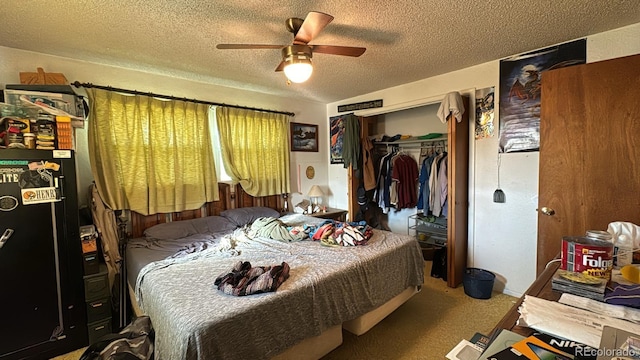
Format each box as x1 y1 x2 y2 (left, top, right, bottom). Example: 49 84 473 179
0 47 329 205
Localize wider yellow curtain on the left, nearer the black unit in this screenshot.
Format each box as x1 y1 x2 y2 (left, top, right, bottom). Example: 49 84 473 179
88 89 218 215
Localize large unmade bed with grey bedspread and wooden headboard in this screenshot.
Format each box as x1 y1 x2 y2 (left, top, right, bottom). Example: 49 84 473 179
126 184 424 359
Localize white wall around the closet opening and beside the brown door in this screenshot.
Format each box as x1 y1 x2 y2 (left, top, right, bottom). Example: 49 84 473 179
327 23 640 296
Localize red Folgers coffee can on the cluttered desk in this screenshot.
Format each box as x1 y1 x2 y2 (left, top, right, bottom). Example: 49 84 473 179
561 230 613 279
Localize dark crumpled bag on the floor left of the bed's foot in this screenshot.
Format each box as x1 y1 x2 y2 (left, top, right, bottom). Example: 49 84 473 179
80 316 155 360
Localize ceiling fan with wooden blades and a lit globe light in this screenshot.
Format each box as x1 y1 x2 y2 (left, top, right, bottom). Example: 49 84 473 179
216 11 367 83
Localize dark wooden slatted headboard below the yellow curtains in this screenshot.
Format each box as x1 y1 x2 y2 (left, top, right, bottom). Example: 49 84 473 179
131 183 286 238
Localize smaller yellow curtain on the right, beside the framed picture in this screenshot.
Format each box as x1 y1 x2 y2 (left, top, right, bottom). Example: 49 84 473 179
216 106 290 196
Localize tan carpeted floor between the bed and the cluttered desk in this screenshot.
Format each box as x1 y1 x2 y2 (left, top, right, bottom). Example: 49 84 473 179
54 261 517 360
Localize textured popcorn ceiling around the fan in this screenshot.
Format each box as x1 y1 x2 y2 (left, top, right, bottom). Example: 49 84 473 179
0 0 640 103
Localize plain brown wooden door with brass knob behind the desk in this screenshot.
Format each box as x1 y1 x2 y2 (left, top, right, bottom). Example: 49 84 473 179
537 55 640 275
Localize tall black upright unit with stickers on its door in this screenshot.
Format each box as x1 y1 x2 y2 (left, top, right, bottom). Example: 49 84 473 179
0 149 88 360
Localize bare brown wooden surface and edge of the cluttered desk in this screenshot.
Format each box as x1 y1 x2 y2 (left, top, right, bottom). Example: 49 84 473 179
490 261 562 337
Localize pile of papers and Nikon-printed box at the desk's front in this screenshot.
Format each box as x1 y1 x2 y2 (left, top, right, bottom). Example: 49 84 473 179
472 294 640 360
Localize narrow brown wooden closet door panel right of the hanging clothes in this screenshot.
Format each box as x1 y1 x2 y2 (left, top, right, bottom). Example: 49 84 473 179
447 96 472 287
